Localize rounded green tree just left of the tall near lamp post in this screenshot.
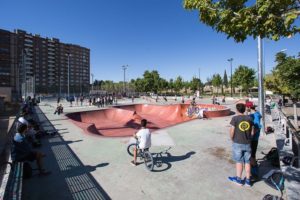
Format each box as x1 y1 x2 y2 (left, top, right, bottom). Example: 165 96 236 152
232 65 255 93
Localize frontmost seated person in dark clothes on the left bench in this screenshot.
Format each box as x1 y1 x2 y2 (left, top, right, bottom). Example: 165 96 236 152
12 124 51 175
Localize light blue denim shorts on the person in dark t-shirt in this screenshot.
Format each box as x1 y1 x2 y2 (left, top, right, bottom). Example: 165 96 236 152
232 143 251 163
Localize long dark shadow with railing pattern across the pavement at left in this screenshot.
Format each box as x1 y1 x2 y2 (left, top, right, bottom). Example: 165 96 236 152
22 107 110 200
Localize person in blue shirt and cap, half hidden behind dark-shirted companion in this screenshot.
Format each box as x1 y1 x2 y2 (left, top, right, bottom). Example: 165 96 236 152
250 105 261 176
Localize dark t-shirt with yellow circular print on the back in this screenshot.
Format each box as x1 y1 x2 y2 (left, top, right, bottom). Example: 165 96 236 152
230 115 253 144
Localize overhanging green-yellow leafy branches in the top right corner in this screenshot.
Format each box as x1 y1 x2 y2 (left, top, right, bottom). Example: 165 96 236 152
184 0 300 42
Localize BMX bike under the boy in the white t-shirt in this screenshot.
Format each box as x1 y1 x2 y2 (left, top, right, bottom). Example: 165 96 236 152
127 140 154 171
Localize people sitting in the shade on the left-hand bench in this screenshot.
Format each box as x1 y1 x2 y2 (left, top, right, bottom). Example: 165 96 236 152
12 98 51 175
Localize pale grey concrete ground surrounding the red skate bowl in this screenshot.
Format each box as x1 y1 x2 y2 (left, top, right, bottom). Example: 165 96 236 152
23 100 279 200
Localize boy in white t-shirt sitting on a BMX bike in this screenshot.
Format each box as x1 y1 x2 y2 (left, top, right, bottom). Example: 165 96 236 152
131 119 151 166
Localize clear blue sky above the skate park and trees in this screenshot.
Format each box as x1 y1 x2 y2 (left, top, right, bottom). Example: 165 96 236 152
0 0 300 81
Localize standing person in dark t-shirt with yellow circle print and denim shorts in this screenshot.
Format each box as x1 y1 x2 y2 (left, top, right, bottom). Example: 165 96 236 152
228 103 254 186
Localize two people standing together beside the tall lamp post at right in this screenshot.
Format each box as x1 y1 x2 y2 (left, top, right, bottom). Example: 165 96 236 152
228 101 261 186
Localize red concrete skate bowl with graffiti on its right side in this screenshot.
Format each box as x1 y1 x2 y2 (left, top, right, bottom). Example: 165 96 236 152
66 104 230 137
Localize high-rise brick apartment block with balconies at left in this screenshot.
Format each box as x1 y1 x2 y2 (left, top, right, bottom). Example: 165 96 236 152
0 29 90 98
